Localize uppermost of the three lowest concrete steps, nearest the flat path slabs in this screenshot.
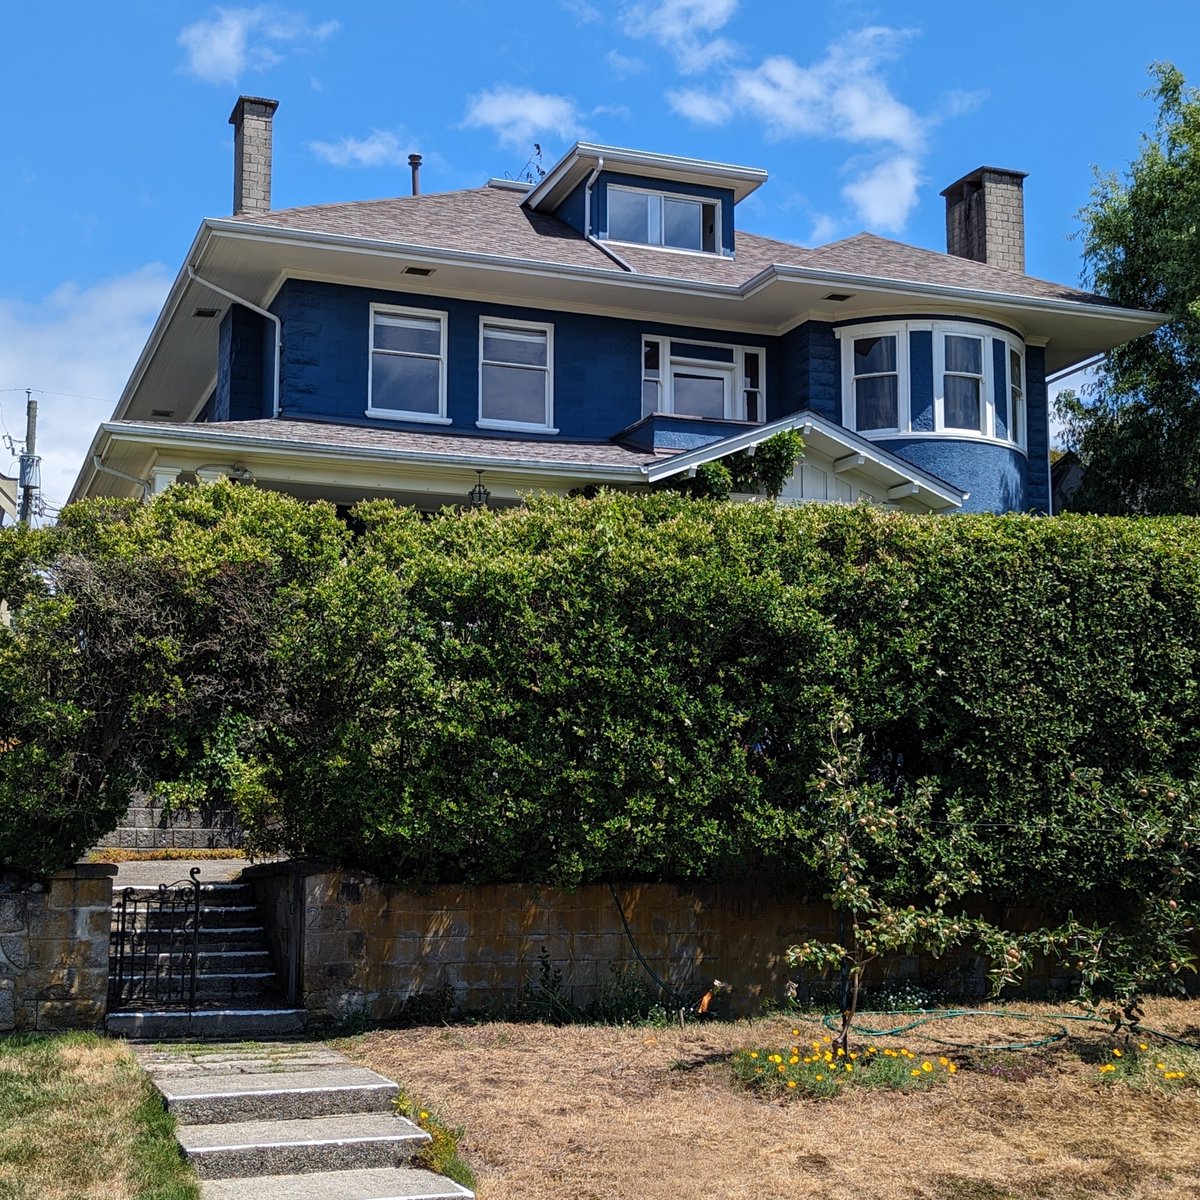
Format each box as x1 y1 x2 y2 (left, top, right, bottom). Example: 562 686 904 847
158 1067 400 1126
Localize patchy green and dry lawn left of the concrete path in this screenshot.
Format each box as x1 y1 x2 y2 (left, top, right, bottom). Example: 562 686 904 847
0 1033 200 1200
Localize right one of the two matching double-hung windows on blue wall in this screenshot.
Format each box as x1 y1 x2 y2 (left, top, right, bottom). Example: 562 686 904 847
479 317 556 433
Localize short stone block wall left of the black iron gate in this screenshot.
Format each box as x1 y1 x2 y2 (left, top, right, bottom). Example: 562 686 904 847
0 863 116 1032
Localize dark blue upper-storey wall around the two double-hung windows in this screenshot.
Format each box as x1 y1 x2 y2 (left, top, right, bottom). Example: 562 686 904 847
271 280 777 440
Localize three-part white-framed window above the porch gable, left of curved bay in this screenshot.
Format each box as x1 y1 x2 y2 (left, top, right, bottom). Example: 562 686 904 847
642 337 764 421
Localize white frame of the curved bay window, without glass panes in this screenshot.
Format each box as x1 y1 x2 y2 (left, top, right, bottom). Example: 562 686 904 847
834 320 1028 454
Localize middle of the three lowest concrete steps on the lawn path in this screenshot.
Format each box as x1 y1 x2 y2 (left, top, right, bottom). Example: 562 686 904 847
176 1112 430 1180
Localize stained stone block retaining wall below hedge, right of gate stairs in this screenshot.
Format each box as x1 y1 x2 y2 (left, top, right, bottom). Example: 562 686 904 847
248 864 1070 1026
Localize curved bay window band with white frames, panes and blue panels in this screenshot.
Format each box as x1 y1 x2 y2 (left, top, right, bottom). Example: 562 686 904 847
836 320 1027 449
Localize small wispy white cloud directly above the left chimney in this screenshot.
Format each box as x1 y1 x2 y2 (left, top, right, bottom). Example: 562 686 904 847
178 5 341 84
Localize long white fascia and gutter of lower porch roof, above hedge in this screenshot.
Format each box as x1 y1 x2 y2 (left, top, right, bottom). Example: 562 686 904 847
98 422 642 482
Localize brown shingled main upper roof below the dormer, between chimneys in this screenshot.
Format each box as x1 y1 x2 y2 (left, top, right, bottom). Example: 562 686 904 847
232 187 1110 305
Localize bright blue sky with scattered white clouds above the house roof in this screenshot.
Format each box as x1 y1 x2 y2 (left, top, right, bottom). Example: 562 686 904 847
0 0 1200 511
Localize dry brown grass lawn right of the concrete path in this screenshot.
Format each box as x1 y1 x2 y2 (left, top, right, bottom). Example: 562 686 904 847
340 1001 1200 1200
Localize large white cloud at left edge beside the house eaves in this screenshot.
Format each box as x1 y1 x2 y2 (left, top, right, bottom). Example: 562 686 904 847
0 263 172 505
